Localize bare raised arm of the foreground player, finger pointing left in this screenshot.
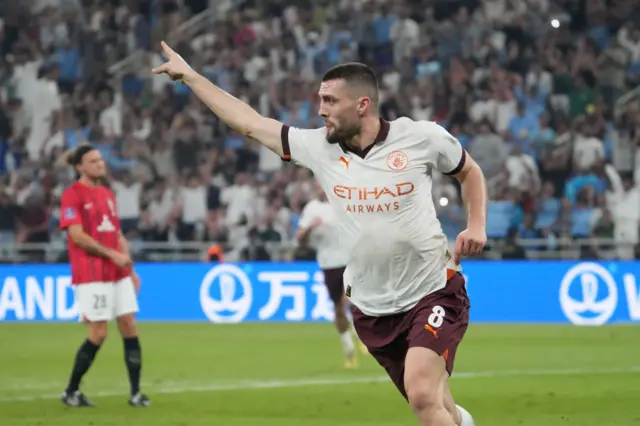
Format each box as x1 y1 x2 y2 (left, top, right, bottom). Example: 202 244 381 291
153 42 290 160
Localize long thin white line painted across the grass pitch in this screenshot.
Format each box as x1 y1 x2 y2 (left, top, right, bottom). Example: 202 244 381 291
0 366 640 402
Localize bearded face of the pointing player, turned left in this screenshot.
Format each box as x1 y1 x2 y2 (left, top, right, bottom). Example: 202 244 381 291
318 80 366 143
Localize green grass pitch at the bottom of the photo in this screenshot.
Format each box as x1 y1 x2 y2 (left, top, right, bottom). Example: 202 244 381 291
0 323 640 426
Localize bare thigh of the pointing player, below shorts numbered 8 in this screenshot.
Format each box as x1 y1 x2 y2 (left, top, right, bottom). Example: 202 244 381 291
404 347 449 410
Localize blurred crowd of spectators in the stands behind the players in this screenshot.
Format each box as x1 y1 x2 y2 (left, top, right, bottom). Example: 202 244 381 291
0 0 640 262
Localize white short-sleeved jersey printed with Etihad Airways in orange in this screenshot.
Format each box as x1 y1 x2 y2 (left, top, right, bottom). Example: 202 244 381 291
282 118 466 316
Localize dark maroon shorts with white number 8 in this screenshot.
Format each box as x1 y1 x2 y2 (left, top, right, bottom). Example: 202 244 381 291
351 273 471 398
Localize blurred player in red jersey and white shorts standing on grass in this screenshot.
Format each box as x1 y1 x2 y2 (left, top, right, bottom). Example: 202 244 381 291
60 145 149 407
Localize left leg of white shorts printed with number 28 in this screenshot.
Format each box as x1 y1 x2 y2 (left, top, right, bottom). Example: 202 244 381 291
75 282 116 323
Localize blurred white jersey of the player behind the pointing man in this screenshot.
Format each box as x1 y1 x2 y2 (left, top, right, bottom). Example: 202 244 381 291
298 200 349 269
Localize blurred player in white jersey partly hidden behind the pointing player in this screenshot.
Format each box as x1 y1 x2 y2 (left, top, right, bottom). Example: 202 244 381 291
297 182 366 369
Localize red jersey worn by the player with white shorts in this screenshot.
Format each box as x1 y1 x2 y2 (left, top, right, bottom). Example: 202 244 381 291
60 182 130 284
